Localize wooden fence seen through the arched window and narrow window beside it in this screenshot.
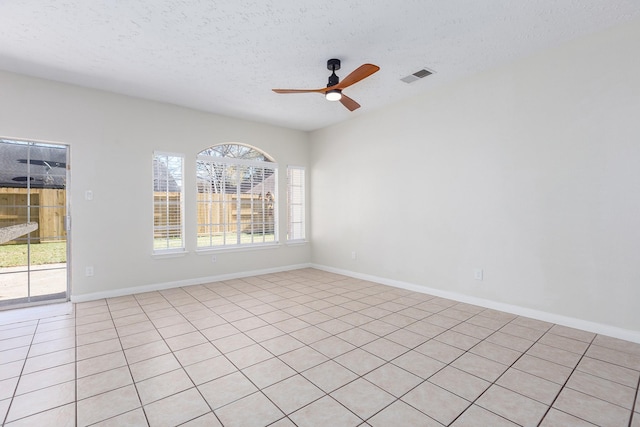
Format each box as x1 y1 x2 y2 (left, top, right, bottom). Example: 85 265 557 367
154 191 274 238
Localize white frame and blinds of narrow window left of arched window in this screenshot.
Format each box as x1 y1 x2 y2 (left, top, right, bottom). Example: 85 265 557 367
151 151 185 255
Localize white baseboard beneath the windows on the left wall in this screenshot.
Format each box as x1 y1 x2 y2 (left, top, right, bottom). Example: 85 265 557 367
71 264 311 303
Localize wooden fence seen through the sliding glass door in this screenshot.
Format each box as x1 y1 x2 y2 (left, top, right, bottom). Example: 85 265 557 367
0 187 67 243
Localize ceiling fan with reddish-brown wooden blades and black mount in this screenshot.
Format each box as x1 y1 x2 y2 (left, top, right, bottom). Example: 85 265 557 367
273 59 380 111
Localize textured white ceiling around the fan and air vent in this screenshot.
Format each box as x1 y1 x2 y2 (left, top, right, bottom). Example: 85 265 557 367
0 0 640 130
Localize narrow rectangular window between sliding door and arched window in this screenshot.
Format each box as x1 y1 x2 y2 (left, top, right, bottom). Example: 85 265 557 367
153 152 184 253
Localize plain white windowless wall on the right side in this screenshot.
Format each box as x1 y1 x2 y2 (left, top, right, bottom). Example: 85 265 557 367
311 21 640 331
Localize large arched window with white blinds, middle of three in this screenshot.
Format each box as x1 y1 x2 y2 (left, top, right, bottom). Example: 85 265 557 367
196 144 278 249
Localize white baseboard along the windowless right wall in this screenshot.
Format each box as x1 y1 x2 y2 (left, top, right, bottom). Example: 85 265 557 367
311 264 640 343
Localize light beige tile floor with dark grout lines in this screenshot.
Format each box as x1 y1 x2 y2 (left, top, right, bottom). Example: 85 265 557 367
0 269 640 427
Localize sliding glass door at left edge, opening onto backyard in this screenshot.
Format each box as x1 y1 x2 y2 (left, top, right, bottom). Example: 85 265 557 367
0 138 69 308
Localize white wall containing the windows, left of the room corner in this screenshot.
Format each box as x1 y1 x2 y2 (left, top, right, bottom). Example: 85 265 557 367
0 72 310 299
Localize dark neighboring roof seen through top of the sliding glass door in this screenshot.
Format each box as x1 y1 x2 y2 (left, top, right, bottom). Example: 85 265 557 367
0 139 67 188
